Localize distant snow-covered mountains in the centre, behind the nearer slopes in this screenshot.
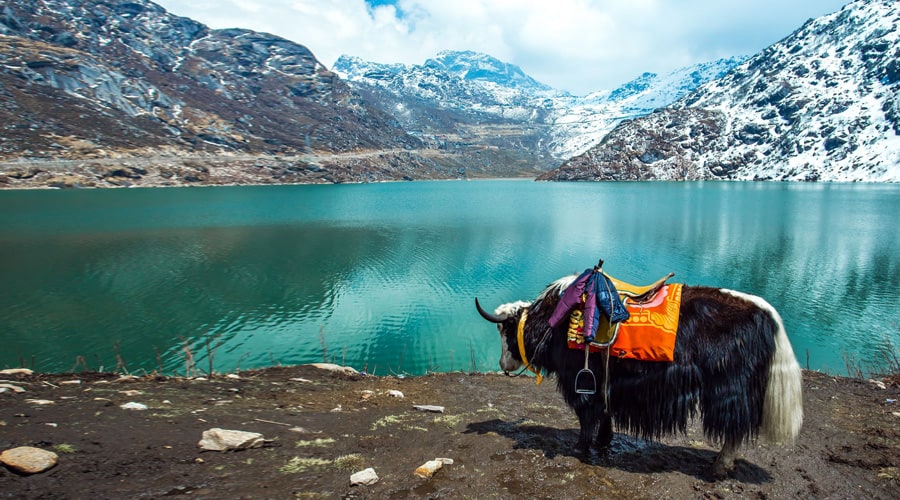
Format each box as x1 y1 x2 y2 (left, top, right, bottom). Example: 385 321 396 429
332 51 744 164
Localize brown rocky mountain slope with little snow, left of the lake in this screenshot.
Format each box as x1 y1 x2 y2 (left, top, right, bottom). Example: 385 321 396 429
0 0 464 182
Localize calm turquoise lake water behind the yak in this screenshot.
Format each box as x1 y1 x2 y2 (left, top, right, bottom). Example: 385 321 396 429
0 180 900 375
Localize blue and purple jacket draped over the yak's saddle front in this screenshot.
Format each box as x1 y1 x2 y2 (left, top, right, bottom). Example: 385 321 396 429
549 268 631 341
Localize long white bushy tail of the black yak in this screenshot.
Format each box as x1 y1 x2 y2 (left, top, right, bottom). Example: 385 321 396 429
760 301 803 444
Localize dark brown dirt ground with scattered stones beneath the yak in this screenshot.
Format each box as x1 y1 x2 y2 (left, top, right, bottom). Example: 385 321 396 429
0 366 900 499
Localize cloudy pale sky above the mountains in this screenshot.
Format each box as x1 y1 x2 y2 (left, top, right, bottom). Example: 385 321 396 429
155 0 847 95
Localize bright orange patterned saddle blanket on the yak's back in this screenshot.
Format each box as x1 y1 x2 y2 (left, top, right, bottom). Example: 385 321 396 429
569 283 682 362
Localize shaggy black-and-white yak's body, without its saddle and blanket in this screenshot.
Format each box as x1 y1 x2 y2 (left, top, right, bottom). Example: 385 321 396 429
475 276 803 477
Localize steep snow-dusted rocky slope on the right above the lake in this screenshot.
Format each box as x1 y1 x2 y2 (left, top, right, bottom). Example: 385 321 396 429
541 0 900 182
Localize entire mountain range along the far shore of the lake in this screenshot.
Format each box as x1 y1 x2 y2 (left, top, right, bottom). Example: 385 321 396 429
0 0 900 187
